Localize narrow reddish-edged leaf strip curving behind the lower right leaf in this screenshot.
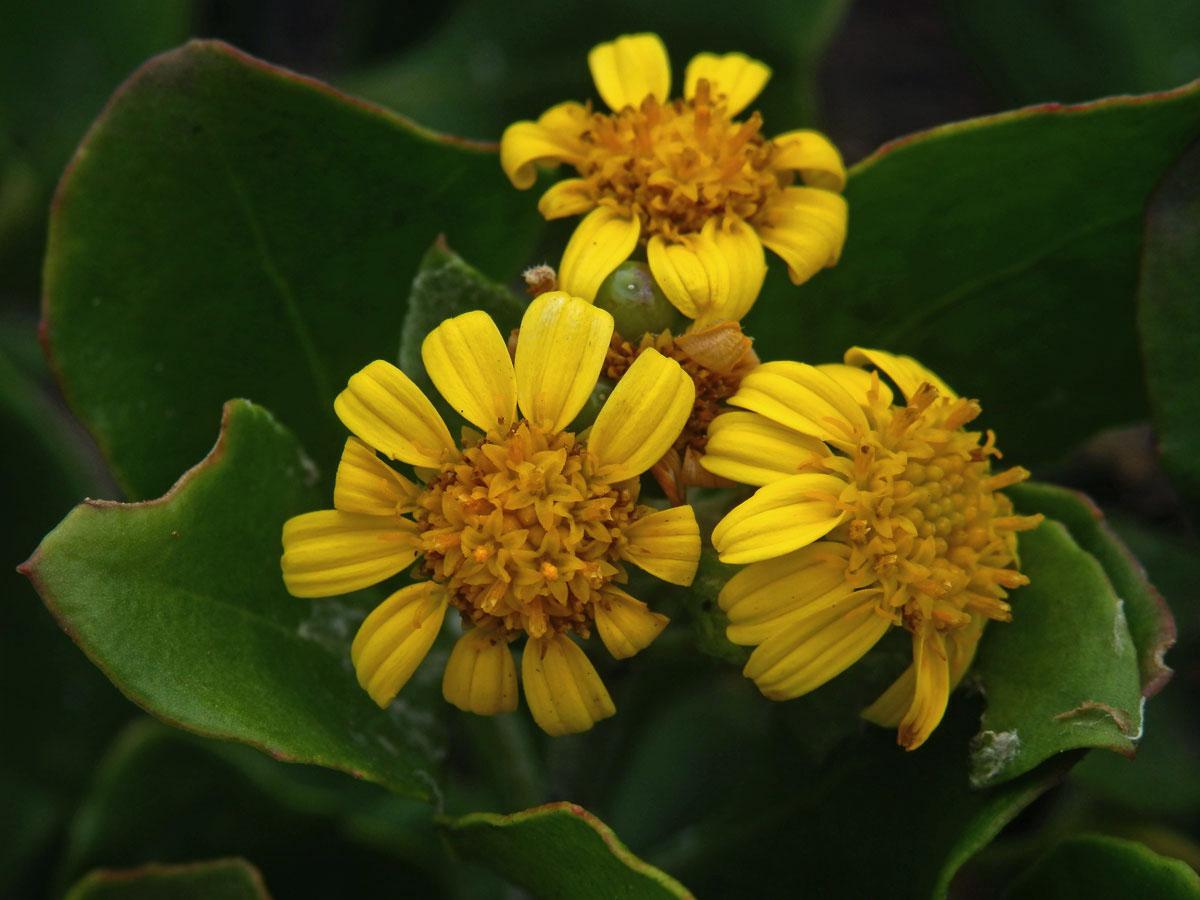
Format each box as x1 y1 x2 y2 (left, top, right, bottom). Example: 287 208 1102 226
1007 482 1175 697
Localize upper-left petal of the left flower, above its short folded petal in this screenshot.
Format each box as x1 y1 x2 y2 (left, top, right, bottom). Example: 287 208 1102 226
334 360 458 467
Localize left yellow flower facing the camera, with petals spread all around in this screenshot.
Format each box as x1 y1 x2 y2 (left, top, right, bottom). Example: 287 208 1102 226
282 293 700 734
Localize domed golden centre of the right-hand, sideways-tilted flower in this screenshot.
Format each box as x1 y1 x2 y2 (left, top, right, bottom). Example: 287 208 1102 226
826 384 1040 631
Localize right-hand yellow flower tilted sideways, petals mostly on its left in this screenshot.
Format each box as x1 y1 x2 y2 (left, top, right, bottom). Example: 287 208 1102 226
701 347 1042 750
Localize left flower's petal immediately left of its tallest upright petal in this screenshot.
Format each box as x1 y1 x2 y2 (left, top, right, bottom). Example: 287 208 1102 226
421 310 517 433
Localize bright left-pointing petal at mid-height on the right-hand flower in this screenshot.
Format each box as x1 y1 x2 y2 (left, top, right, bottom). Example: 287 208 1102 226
713 474 847 564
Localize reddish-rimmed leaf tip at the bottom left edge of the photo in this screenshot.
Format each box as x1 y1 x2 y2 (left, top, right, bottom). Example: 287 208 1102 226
67 859 271 900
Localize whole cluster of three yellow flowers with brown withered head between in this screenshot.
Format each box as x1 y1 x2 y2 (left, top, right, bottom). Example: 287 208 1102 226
282 35 1040 749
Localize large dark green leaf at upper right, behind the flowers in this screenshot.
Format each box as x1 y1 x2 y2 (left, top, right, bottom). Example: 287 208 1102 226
745 86 1200 463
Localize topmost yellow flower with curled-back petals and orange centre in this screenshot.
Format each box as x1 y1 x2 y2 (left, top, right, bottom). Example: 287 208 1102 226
500 35 846 324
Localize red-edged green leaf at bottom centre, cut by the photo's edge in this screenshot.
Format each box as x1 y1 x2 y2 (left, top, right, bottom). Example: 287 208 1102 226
439 803 691 900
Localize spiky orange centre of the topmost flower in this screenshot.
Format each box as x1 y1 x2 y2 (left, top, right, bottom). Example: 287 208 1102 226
577 79 791 244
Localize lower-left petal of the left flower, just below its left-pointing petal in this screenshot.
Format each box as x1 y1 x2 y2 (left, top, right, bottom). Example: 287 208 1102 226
350 581 446 707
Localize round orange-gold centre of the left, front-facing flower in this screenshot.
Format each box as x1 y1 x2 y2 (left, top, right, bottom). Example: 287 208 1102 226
415 421 644 638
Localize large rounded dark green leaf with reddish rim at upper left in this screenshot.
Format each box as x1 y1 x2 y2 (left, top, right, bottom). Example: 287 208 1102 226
44 42 542 498
